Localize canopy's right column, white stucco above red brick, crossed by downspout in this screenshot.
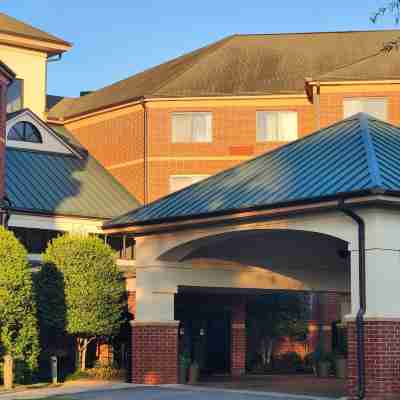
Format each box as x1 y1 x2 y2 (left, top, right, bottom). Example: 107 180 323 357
347 247 400 400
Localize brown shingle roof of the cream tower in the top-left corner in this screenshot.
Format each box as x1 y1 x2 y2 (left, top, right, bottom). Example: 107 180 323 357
0 13 71 46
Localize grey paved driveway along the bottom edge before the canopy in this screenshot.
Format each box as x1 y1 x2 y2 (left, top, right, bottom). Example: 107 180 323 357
71 388 328 400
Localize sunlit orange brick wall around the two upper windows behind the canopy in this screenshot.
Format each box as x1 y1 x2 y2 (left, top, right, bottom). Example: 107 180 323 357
148 104 315 201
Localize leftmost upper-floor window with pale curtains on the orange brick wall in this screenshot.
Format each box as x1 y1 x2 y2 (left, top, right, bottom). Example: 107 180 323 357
172 112 212 143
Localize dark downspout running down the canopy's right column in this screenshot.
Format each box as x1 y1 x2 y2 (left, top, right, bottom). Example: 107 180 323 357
339 200 367 400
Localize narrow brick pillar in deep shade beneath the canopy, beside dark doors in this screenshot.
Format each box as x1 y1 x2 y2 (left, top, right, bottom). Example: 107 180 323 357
231 299 246 376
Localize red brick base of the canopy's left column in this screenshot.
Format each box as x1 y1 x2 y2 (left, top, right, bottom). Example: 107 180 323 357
131 321 179 385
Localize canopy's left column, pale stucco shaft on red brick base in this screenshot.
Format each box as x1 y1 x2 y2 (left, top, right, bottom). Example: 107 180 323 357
131 287 179 385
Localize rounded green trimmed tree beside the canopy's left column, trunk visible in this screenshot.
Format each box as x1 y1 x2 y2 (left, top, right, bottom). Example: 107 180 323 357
44 234 124 370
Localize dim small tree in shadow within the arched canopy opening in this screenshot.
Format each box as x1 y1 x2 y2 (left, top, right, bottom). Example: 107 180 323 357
248 293 307 367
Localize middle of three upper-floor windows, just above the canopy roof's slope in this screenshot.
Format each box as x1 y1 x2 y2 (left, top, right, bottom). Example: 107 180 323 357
257 111 297 142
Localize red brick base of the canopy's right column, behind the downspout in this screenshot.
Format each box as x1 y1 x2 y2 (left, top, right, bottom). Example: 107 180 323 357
347 320 400 400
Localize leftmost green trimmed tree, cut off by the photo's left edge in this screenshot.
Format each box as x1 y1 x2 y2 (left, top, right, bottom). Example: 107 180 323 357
0 227 39 380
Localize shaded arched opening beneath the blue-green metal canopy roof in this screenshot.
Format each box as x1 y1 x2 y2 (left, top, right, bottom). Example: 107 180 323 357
169 229 350 395
